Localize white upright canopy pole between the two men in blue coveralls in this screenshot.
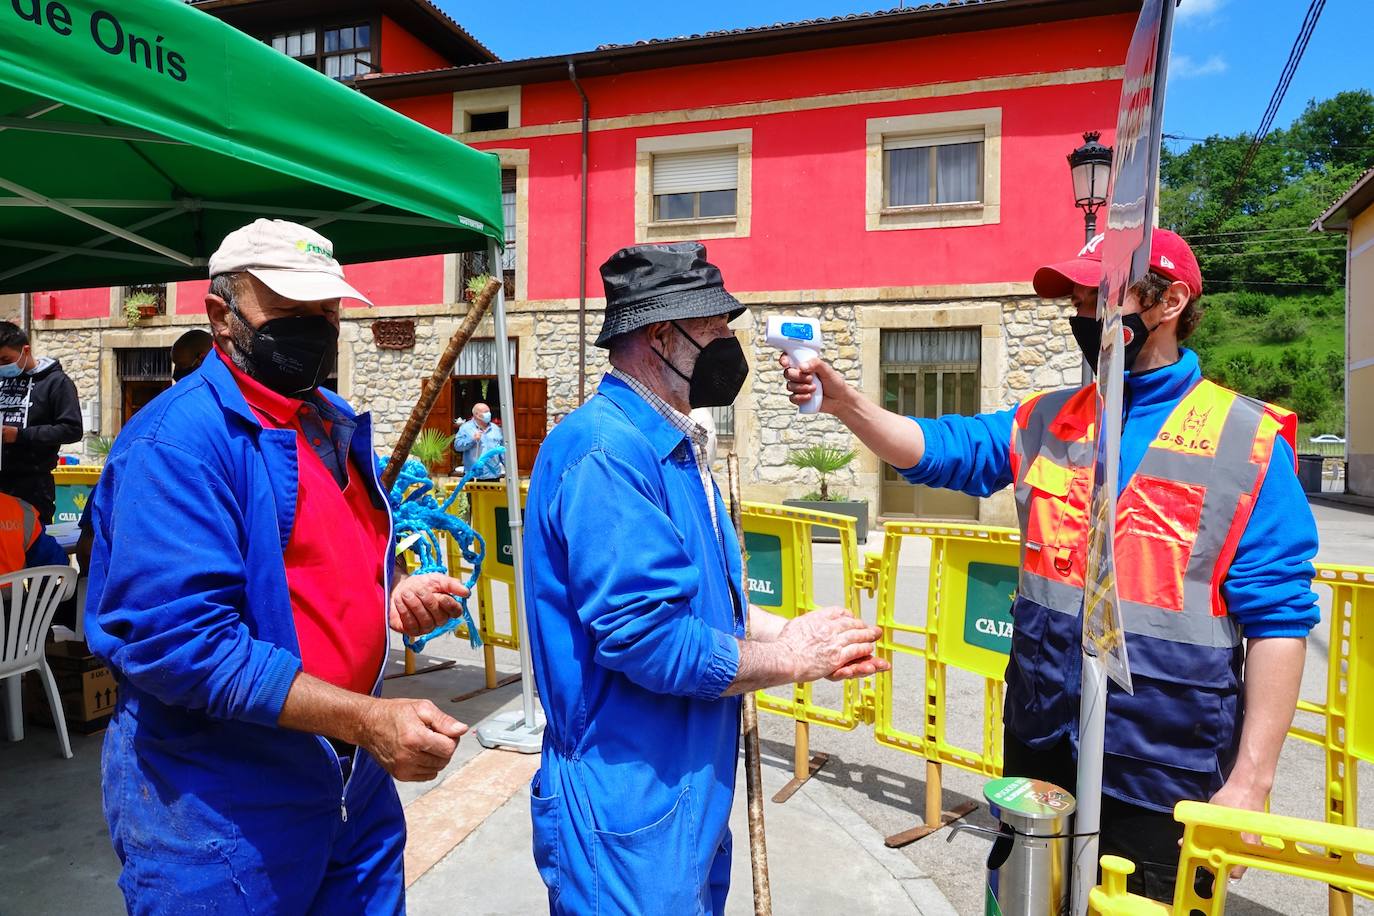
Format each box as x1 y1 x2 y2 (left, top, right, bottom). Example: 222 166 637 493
477 242 544 754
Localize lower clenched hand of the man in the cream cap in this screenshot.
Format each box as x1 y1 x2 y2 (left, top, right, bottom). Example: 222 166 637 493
359 699 467 783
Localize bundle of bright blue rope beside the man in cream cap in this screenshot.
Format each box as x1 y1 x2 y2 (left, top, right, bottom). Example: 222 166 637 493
378 448 506 652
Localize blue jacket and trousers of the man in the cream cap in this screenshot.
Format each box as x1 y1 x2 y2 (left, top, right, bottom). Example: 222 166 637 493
85 358 405 913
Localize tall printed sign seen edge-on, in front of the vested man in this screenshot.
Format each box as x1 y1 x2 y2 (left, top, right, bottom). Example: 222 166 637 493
1083 0 1173 692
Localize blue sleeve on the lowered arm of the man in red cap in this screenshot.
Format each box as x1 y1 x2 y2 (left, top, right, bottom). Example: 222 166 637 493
1221 439 1322 639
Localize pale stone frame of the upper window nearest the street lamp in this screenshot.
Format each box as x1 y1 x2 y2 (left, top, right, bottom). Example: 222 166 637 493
864 108 1002 232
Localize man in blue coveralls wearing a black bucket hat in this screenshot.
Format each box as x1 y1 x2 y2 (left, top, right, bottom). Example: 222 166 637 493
525 242 886 913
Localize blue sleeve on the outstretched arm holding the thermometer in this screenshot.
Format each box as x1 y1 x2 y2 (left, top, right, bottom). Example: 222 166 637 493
896 407 1017 496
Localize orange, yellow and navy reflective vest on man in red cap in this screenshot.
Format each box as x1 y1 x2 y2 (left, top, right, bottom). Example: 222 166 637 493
1006 379 1297 810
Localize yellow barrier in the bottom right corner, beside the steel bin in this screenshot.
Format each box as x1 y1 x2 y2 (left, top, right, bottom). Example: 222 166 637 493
1088 802 1374 916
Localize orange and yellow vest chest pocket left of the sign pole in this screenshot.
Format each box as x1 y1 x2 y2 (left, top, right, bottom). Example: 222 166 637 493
1025 455 1092 586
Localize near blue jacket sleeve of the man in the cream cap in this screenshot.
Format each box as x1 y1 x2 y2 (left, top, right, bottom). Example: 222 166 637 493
85 438 301 725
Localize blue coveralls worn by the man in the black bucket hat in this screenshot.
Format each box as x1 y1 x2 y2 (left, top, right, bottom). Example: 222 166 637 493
525 378 743 916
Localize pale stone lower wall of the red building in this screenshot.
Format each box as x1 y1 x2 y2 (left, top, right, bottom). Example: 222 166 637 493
26 297 1081 511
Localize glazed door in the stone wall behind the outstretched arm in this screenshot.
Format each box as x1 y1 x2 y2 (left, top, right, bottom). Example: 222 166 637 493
879 328 982 520
